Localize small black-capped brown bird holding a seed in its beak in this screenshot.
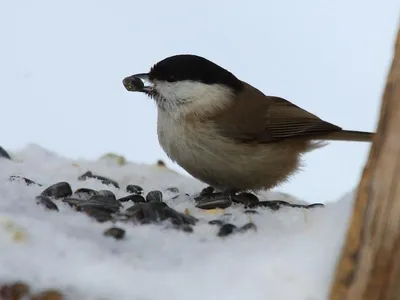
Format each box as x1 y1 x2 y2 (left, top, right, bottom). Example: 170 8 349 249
123 54 373 193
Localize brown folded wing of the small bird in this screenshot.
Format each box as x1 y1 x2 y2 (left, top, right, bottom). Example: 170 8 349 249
213 84 342 143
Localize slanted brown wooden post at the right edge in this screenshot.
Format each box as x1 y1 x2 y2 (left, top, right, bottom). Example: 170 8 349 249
330 19 400 300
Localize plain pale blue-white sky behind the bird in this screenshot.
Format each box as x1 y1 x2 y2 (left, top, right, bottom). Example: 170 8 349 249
0 0 400 202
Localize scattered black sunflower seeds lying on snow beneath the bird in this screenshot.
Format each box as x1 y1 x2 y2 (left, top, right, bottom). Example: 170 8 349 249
9 171 322 239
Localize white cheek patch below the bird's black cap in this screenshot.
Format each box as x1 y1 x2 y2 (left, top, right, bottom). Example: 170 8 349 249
154 80 234 114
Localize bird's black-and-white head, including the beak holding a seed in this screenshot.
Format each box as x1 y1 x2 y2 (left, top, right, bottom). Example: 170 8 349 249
123 54 243 114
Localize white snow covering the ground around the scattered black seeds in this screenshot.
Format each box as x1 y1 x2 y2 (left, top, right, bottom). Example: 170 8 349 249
0 145 354 300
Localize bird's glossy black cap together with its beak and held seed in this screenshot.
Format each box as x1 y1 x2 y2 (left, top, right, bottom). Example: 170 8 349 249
124 54 242 93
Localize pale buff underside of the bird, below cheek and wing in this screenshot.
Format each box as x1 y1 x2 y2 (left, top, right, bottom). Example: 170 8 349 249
158 116 304 189
